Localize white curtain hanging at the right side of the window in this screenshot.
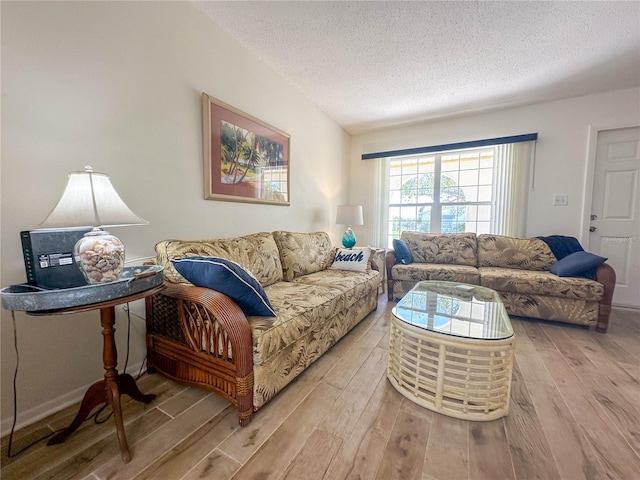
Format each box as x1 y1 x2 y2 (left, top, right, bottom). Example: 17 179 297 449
491 141 535 237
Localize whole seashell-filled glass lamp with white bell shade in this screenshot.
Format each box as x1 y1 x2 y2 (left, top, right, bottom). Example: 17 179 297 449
38 167 149 285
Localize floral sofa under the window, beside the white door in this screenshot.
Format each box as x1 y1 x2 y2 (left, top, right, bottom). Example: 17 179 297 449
386 231 615 333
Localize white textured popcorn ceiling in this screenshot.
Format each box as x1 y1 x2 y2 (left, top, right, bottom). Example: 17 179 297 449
194 1 640 134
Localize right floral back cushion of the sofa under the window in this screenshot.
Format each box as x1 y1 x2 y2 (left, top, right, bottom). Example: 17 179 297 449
478 234 556 271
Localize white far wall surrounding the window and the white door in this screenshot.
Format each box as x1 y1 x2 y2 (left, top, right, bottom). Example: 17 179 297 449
350 88 640 248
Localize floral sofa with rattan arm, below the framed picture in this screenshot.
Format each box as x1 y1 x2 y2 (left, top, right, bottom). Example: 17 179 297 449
146 231 382 425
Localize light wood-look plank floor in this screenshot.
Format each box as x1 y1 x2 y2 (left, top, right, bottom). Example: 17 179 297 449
1 296 640 480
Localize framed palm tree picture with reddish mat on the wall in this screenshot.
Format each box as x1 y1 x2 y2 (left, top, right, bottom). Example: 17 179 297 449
202 93 290 206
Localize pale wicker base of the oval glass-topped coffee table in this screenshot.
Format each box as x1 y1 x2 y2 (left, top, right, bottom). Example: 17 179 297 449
387 315 515 421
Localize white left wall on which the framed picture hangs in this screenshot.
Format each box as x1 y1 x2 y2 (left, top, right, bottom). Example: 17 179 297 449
1 2 350 433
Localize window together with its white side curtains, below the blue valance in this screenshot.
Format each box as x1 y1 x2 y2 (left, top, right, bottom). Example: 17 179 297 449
377 139 537 247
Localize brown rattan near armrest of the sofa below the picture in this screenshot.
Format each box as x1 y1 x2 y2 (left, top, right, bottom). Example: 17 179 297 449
146 282 253 425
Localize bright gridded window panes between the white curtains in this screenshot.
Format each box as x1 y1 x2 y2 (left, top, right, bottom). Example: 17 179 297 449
388 147 495 245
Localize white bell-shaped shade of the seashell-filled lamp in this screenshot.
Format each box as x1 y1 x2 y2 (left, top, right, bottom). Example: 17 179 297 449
38 167 149 228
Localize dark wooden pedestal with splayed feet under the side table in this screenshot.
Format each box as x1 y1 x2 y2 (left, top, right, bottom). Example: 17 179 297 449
48 306 156 463
